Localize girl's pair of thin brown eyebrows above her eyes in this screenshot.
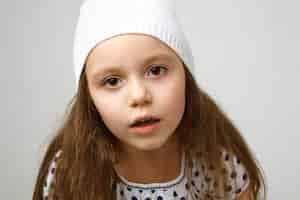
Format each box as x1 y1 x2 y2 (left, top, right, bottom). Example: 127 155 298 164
92 53 174 79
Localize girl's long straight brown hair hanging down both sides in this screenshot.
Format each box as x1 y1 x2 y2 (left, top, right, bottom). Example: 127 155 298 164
33 63 266 200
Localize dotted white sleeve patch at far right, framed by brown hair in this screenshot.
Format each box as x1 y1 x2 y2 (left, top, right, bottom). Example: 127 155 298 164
222 151 250 200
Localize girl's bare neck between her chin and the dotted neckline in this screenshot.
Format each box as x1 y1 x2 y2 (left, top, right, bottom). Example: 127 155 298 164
115 134 183 184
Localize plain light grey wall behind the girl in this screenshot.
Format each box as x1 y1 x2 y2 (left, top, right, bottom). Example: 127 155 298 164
0 0 300 200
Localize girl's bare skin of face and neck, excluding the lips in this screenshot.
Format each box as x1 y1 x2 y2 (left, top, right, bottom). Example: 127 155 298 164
86 34 185 183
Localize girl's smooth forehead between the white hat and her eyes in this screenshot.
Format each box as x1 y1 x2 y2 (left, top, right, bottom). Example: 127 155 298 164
86 34 179 74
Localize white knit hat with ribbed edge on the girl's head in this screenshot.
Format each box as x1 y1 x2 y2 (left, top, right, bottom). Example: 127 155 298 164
73 0 194 86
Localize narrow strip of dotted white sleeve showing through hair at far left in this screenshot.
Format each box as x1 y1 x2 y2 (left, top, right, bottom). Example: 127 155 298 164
43 150 61 200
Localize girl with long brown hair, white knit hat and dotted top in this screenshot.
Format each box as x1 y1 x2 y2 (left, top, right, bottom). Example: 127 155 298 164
33 0 266 200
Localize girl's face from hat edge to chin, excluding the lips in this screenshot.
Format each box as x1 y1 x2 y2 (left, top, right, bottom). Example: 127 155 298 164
86 34 185 154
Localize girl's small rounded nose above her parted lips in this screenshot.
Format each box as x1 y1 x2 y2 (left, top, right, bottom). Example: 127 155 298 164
129 79 152 107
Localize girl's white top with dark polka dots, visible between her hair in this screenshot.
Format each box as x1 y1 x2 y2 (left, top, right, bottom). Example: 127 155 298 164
43 151 250 200
